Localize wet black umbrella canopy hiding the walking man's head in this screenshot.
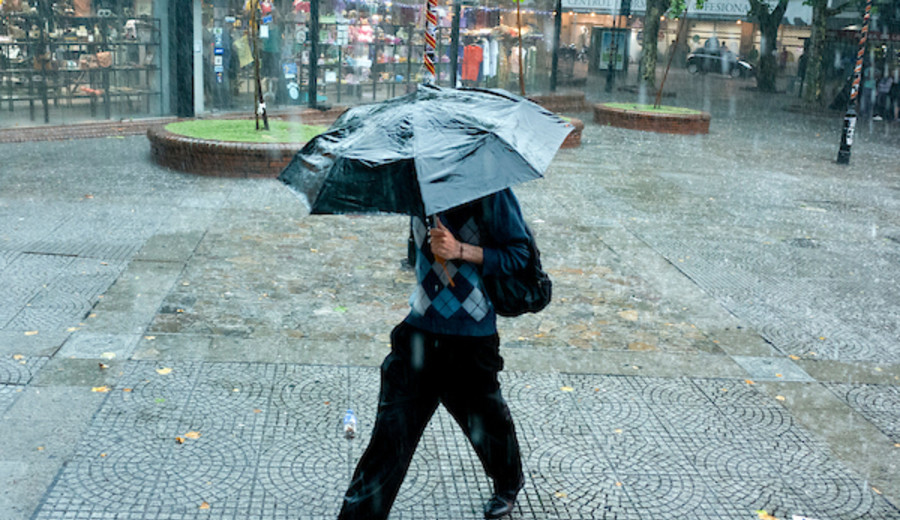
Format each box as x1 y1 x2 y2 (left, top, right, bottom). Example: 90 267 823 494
279 85 573 215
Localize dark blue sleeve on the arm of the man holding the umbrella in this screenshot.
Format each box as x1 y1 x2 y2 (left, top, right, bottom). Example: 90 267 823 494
481 189 530 276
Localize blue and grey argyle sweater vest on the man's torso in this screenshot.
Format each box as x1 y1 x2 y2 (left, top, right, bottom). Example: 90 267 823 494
406 211 497 336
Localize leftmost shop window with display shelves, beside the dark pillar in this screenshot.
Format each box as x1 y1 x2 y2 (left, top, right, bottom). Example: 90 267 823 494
0 0 164 126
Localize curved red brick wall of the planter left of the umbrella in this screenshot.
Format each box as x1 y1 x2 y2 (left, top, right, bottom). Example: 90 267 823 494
147 108 345 178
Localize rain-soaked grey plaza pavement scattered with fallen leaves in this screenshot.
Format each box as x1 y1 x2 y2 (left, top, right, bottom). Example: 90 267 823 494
0 70 900 520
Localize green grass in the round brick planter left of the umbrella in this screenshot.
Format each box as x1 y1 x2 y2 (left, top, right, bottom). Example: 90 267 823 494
166 119 327 143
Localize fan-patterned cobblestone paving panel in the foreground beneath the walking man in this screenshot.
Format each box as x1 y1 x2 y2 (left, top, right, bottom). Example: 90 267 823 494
28 362 900 520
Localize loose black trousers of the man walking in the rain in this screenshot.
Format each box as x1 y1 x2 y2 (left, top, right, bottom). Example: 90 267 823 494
339 323 524 520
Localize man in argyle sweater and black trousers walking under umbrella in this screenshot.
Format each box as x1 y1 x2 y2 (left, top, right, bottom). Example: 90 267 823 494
339 189 530 520
